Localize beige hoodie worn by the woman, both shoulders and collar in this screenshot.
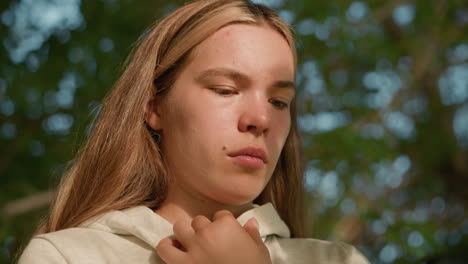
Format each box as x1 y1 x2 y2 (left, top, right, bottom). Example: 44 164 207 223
19 203 369 264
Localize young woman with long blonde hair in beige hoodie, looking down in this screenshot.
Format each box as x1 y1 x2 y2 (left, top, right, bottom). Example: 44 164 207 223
19 0 367 264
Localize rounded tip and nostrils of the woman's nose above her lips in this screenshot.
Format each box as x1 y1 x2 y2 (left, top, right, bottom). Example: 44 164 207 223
238 101 270 136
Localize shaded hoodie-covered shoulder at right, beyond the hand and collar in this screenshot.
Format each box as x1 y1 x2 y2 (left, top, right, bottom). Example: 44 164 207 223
266 237 369 264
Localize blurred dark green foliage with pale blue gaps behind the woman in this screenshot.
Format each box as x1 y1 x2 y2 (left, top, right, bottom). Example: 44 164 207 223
0 0 468 263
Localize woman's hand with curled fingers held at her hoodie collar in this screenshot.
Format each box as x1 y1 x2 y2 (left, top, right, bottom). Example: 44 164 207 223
156 210 271 264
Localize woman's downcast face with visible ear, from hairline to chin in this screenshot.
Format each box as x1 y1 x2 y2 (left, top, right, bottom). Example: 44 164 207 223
149 24 295 205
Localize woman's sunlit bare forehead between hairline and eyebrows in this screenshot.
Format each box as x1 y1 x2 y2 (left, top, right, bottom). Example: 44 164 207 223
189 24 294 79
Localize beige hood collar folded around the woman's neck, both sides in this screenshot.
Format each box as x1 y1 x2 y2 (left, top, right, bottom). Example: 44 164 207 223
80 203 290 247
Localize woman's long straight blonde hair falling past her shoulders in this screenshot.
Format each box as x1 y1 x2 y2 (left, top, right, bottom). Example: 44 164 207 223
36 0 304 237
